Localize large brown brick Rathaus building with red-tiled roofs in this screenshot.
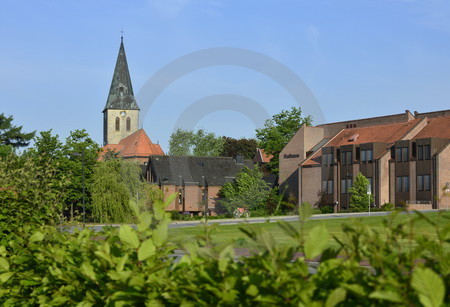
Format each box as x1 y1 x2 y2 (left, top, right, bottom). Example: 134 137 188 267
279 110 450 209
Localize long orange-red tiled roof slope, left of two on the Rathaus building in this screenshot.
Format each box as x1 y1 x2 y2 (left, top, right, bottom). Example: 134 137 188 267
327 119 420 146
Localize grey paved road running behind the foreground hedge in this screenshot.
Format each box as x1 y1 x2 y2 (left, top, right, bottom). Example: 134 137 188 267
69 210 438 231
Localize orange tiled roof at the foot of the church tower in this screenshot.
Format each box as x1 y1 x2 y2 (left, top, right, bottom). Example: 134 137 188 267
101 129 164 158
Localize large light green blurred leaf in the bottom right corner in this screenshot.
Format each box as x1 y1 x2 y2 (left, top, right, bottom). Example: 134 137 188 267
411 268 445 307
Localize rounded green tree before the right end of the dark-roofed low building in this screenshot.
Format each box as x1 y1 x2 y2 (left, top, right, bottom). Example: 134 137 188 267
219 167 270 213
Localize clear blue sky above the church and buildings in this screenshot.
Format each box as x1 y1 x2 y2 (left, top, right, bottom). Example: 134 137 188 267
0 0 450 150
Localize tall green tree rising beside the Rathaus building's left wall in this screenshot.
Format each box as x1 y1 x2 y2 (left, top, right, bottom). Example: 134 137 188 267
256 107 312 173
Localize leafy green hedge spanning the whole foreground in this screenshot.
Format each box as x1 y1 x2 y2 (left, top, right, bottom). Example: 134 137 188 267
0 199 450 306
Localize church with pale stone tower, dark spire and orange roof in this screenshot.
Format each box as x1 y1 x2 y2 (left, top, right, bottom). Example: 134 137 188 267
100 37 164 164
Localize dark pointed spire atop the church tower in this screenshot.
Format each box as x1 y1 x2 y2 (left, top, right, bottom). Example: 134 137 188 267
103 39 139 111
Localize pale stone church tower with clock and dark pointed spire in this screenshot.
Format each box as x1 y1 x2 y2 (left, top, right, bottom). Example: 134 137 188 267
103 37 139 145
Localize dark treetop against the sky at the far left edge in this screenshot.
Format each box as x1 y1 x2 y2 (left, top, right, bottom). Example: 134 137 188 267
0 113 35 147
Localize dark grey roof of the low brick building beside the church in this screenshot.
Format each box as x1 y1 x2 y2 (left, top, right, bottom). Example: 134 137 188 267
148 156 253 186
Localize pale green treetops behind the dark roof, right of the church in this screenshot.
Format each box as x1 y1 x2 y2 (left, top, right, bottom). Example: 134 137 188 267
169 128 223 157
